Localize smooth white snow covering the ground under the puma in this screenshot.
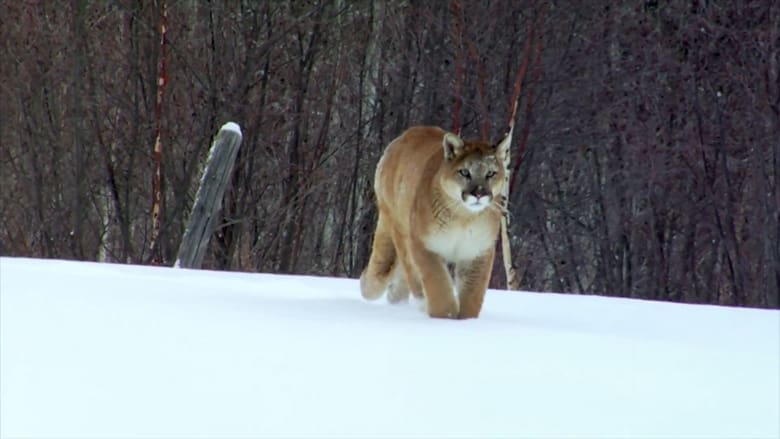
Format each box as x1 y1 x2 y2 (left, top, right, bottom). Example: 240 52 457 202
0 258 780 438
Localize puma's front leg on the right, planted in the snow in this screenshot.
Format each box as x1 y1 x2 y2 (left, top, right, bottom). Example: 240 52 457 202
455 248 495 319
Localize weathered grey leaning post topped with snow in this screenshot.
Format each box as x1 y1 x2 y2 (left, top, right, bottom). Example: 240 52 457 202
174 122 241 268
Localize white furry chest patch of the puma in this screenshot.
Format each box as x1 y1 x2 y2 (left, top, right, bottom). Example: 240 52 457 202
425 220 498 262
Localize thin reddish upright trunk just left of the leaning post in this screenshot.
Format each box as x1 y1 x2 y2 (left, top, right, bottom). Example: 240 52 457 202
149 0 168 264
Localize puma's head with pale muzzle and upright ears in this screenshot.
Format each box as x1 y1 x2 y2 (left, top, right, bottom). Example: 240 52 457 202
440 133 510 213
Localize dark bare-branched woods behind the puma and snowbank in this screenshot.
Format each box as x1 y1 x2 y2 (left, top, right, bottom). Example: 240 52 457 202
0 0 780 308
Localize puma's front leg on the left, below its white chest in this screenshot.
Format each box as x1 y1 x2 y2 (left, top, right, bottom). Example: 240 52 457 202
409 241 458 319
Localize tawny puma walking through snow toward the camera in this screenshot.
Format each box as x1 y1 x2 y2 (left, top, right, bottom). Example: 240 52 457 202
360 127 510 319
